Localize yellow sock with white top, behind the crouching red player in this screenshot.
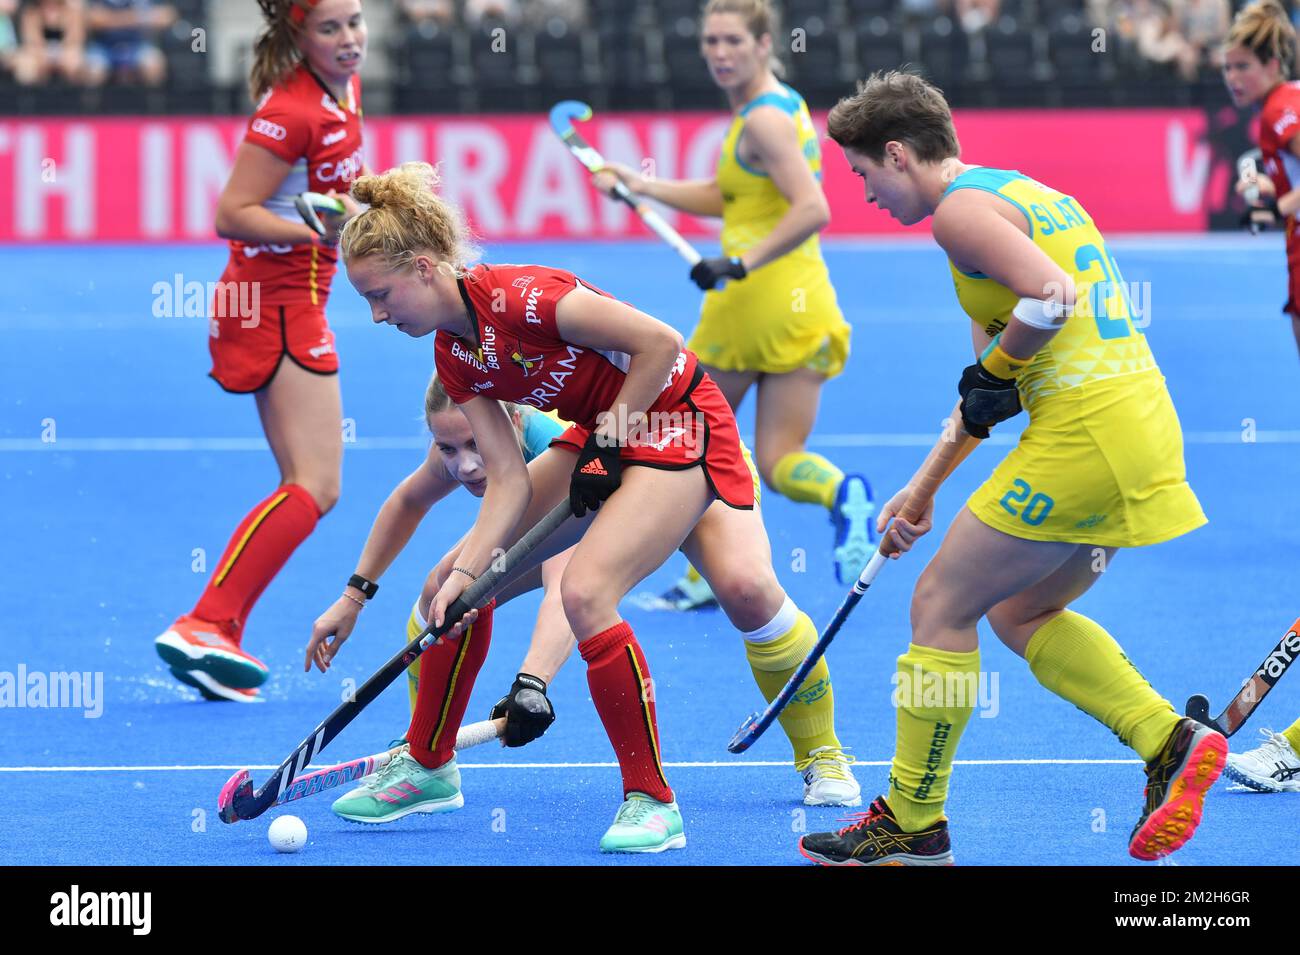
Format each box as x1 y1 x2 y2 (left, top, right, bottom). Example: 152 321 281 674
742 598 840 769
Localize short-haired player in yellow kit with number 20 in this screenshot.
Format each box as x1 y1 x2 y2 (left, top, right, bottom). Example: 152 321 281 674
800 73 1227 865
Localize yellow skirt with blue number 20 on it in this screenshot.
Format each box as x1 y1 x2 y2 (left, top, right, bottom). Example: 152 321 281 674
966 369 1205 547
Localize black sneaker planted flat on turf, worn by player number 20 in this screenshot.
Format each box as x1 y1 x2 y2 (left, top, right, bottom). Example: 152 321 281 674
800 796 953 865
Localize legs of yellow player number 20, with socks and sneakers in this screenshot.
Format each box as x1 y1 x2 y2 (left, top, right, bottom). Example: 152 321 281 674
802 508 1227 864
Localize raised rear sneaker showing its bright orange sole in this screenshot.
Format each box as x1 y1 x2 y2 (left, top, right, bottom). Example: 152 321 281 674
1128 717 1227 861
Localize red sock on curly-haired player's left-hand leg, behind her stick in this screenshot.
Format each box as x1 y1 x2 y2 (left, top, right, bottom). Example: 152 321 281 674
407 600 497 769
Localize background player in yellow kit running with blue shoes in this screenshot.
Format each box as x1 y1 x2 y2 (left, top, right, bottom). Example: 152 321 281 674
595 0 875 608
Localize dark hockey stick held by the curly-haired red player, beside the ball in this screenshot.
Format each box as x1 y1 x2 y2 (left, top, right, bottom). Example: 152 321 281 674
217 498 573 822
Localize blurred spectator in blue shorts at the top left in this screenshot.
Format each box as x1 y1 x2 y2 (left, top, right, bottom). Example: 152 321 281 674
86 0 177 86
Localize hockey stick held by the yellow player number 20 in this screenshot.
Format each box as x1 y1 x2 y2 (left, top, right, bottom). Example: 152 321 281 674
727 429 979 752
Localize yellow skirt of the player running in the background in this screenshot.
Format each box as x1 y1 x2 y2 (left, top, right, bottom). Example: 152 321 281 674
686 259 850 378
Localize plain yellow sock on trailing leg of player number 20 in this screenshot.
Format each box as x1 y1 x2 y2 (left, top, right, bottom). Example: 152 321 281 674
1024 611 1179 763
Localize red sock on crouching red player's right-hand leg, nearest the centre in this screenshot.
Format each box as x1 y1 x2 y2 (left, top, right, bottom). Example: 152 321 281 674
577 622 672 803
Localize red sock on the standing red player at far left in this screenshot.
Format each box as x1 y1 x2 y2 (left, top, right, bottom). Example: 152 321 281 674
194 485 321 642
